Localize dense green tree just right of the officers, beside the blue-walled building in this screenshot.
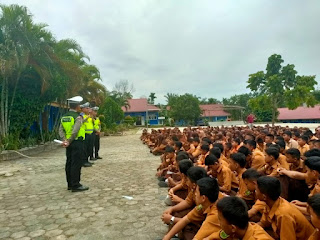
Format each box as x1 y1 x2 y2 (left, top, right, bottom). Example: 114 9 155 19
99 97 124 128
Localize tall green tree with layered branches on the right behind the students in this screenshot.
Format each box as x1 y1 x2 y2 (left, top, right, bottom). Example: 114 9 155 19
247 54 317 125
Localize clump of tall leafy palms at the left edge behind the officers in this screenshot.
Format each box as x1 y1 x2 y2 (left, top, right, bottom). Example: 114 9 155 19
0 5 105 144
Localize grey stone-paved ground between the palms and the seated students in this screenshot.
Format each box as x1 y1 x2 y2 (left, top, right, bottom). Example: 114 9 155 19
0 134 167 240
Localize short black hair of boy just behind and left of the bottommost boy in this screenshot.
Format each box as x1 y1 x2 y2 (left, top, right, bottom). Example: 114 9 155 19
197 177 219 203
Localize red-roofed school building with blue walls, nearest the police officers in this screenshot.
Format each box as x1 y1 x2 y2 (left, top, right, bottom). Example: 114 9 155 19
122 98 160 126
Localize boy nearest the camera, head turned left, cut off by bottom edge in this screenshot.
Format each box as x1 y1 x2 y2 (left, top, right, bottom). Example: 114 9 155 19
206 197 273 240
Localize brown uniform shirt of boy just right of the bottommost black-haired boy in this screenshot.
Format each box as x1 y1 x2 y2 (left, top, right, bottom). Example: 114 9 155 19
260 197 314 240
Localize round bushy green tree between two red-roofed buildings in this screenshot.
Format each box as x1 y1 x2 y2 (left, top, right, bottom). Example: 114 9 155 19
170 93 202 124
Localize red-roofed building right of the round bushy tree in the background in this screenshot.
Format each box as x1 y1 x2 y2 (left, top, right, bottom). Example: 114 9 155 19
200 104 231 122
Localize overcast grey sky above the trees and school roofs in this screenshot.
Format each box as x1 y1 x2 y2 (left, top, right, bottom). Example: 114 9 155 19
1 0 320 103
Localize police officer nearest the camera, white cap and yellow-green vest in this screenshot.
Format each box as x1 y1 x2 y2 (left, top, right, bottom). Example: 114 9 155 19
59 98 89 192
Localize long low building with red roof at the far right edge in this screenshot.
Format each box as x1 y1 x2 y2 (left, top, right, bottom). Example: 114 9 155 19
278 105 320 123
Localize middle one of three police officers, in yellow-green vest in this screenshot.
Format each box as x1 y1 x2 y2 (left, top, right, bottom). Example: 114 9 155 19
81 102 95 167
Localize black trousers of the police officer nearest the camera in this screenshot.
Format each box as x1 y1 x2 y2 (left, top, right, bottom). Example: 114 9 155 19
65 140 84 188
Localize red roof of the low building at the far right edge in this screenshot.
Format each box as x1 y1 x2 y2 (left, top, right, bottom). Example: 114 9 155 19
278 105 320 120
